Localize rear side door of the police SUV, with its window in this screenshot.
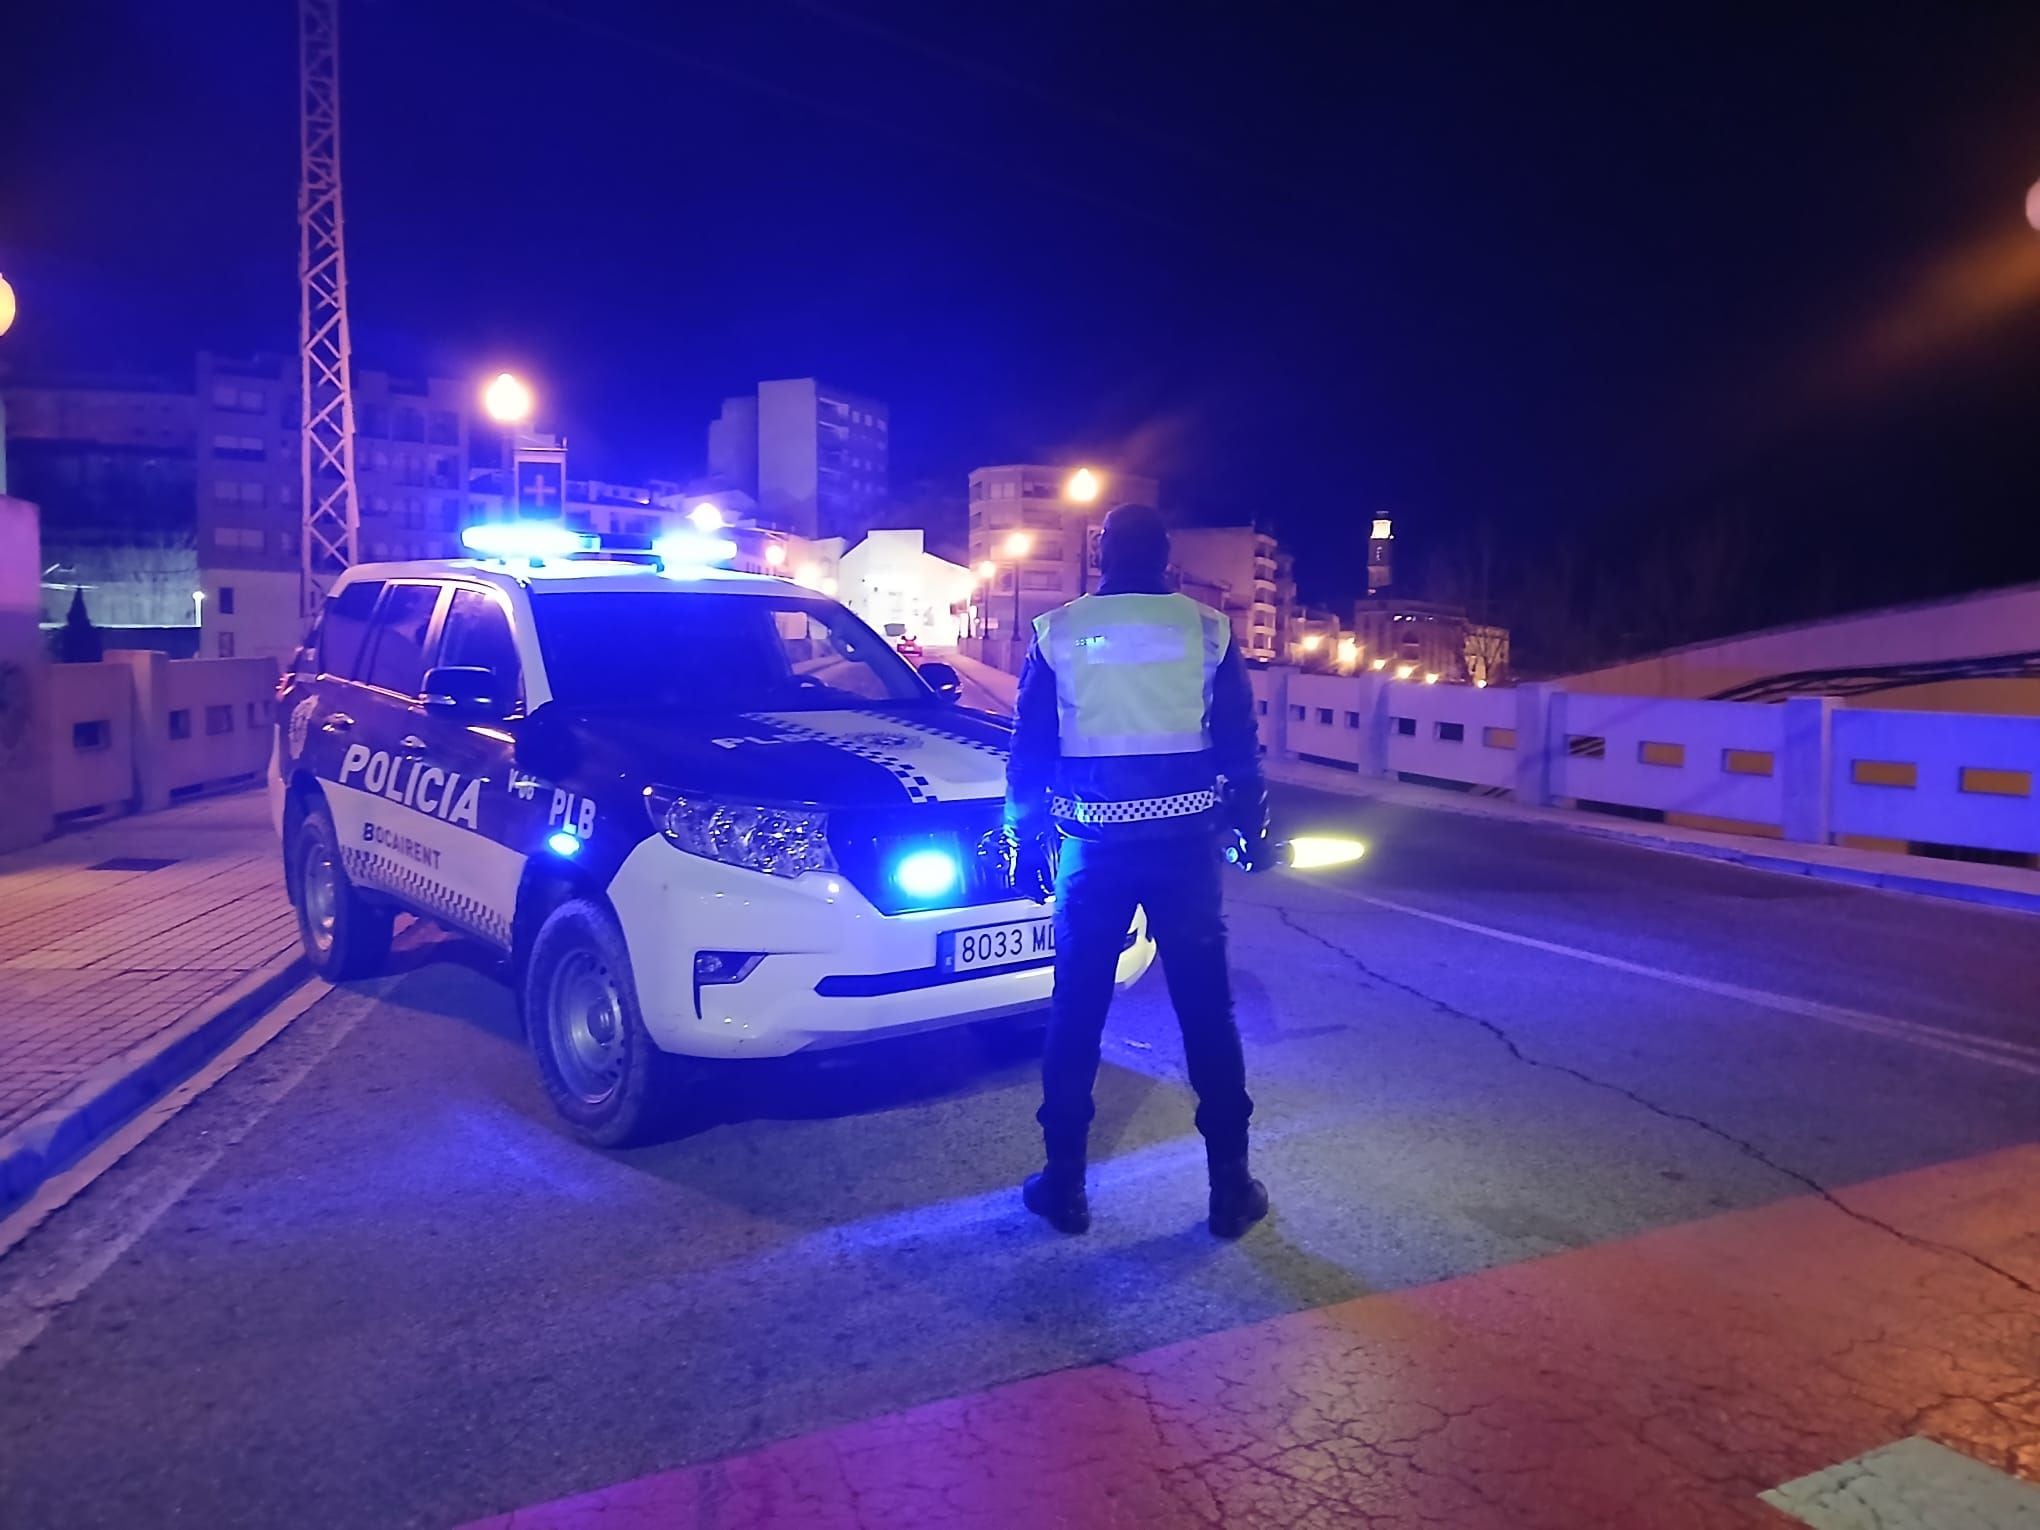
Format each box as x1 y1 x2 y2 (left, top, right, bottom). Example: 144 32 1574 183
320 579 449 912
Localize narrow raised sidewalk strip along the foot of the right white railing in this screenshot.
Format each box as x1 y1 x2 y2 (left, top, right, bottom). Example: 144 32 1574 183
1267 757 2040 914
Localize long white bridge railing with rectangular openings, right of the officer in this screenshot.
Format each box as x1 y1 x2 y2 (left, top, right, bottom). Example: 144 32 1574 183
1255 669 2040 855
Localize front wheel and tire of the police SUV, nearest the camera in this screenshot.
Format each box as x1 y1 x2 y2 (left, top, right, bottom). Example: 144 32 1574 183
520 898 692 1149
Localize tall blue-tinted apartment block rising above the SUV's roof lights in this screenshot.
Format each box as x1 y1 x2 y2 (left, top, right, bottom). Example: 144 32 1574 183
708 377 891 537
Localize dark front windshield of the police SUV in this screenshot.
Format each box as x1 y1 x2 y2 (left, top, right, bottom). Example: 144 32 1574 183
530 590 934 712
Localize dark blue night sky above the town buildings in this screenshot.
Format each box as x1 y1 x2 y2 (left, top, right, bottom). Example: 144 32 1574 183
0 0 2040 665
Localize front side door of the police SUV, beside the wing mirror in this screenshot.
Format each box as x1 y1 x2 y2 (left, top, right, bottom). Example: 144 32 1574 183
410 583 545 949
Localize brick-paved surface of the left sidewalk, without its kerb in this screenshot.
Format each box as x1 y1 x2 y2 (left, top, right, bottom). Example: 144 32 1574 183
0 792 298 1136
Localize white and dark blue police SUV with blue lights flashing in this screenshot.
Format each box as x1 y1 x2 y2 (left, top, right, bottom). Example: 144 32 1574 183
271 528 1153 1146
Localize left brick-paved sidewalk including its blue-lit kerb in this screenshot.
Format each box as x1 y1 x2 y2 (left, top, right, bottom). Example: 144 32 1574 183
0 792 302 1206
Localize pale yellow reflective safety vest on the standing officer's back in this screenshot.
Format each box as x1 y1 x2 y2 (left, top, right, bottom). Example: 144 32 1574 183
1034 596 1232 759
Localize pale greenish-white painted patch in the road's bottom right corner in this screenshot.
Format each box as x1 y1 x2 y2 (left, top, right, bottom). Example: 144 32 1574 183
1758 1434 2040 1530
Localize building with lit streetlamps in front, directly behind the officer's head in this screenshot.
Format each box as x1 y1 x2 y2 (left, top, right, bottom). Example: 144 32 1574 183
969 463 1161 639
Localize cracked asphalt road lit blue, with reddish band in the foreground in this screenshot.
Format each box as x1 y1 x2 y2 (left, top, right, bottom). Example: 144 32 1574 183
0 792 2040 1528
